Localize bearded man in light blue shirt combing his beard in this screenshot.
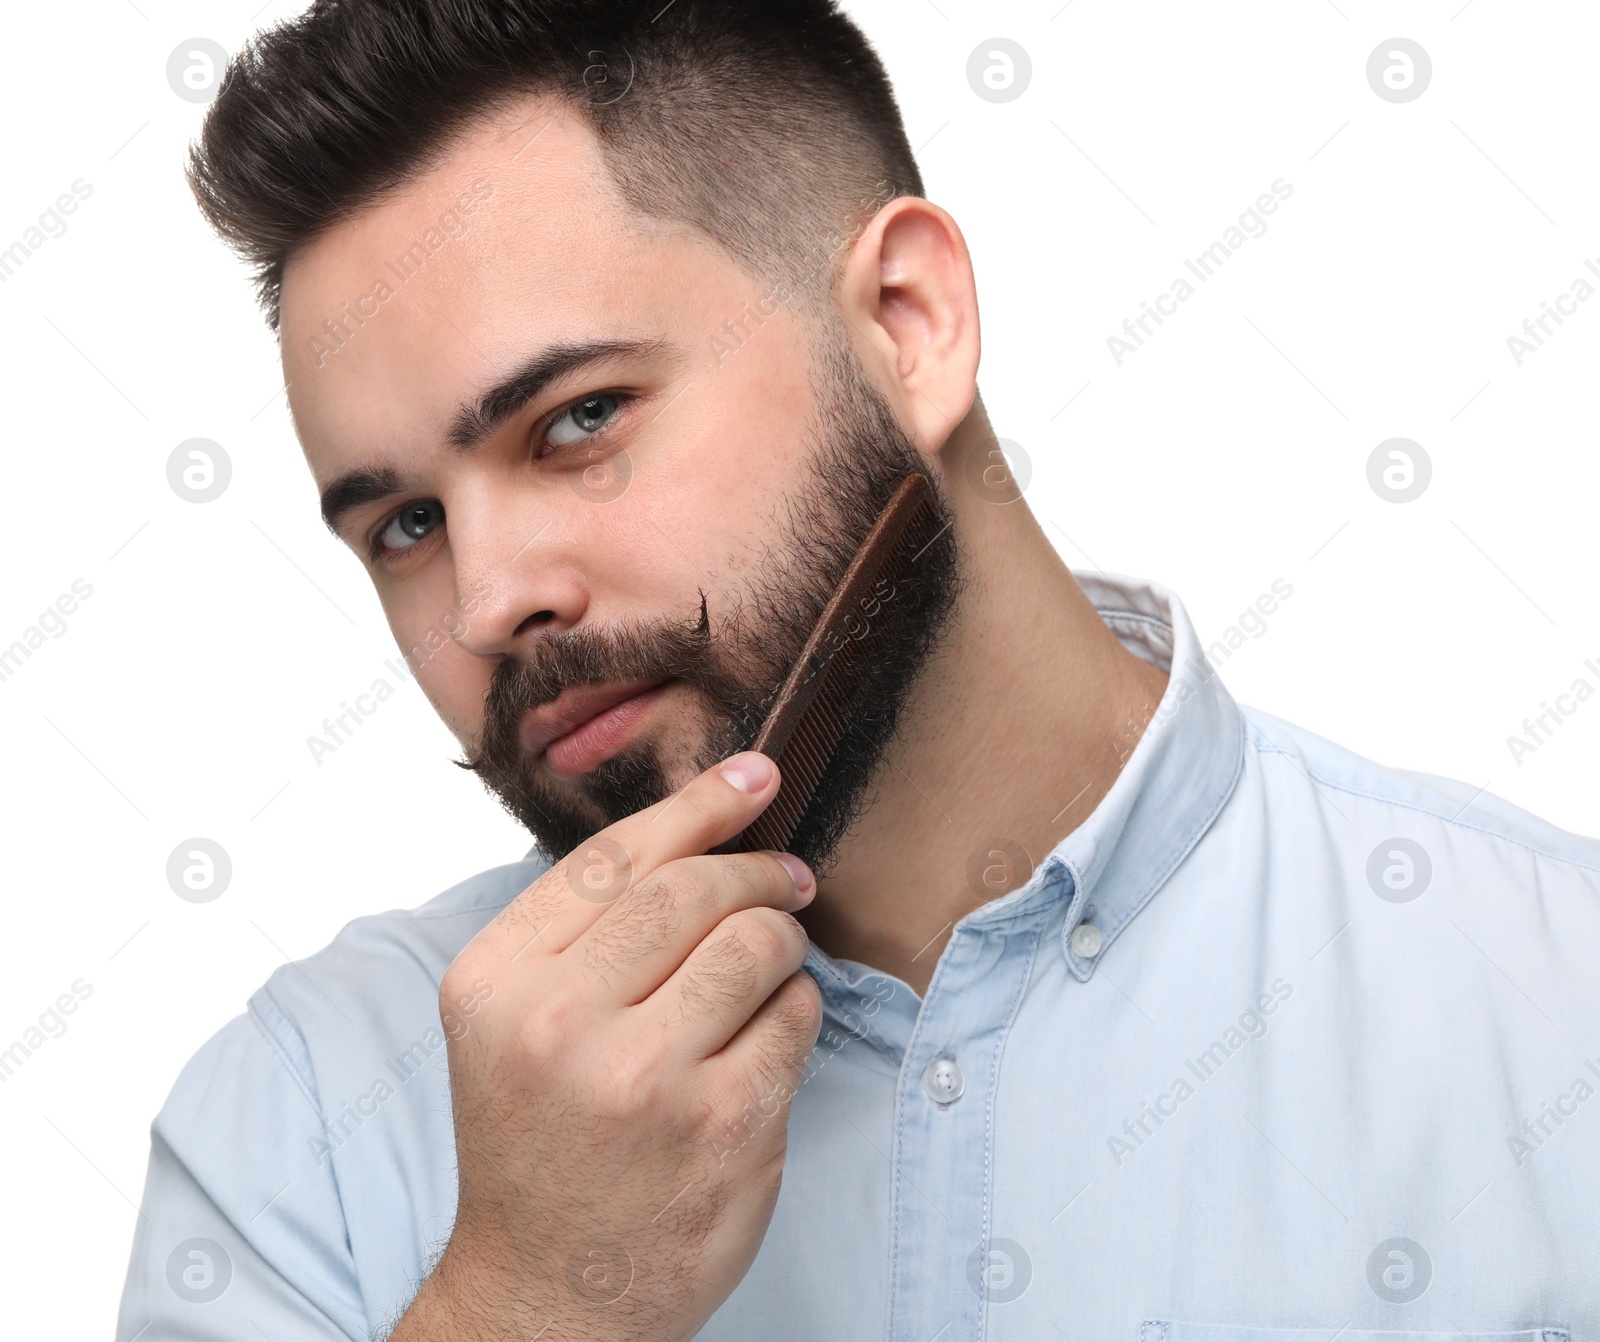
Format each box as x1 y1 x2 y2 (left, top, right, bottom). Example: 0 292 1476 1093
118 0 1600 1342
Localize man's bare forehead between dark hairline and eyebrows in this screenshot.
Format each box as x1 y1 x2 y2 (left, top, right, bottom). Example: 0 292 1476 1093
280 99 720 478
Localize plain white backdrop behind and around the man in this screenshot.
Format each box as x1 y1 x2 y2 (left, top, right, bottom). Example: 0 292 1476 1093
0 0 1600 1337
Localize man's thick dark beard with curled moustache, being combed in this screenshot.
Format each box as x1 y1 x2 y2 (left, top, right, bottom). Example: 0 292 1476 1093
458 323 965 877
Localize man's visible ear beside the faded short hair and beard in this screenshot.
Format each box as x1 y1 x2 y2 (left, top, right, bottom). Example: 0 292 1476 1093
838 195 979 456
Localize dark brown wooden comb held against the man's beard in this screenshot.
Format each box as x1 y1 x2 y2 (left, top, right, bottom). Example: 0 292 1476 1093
710 472 939 853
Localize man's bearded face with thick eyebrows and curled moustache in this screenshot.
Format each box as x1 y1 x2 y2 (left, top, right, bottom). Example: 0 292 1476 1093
282 104 957 869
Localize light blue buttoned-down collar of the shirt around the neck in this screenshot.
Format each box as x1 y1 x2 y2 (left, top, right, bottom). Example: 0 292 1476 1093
806 569 1245 992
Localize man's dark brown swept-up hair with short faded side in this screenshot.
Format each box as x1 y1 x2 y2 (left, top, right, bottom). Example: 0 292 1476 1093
186 0 923 331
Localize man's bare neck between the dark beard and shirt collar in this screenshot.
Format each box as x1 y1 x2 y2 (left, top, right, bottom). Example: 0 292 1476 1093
798 408 1166 993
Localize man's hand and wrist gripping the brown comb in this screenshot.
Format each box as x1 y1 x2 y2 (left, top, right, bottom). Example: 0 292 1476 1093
392 752 822 1342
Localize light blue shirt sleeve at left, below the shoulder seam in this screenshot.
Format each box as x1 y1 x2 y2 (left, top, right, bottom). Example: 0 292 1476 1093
117 992 370 1342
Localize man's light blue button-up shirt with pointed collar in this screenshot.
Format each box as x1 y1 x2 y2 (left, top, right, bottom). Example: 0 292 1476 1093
117 573 1600 1342
